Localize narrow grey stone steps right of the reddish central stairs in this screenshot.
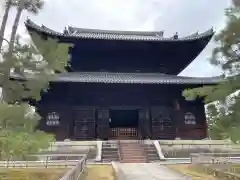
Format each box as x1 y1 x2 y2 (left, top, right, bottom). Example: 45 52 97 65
143 143 160 163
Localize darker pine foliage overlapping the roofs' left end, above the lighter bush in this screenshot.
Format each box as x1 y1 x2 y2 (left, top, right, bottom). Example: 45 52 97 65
0 34 69 103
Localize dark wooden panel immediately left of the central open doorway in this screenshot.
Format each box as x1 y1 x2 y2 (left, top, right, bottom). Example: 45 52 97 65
97 109 110 140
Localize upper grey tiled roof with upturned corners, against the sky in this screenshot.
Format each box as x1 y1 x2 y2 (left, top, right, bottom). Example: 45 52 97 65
25 19 214 41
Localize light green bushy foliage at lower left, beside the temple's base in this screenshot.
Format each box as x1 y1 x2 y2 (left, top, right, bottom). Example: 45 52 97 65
0 100 54 160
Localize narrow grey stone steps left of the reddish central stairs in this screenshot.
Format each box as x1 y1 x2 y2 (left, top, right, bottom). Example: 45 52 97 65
102 141 120 162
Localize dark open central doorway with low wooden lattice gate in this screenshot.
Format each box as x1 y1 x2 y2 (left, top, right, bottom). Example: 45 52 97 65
109 110 138 139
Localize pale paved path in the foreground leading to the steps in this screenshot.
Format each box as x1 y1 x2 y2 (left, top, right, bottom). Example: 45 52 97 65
117 163 191 180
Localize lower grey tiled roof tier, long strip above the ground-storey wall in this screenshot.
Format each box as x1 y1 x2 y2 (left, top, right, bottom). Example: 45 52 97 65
9 72 223 84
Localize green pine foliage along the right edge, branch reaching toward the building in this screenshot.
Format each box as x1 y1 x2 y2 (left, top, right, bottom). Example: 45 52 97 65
183 7 240 143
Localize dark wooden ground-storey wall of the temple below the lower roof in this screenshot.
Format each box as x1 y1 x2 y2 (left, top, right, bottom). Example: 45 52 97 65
39 83 206 140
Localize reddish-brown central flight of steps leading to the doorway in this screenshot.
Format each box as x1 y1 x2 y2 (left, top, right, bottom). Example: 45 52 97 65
119 141 147 163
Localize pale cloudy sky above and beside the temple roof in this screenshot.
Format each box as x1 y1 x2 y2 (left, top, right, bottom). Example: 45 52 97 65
0 0 230 77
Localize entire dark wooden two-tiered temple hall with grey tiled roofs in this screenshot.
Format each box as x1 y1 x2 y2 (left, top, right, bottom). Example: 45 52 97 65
26 20 216 140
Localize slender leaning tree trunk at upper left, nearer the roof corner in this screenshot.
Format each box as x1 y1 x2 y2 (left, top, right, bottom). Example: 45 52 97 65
8 5 23 54
